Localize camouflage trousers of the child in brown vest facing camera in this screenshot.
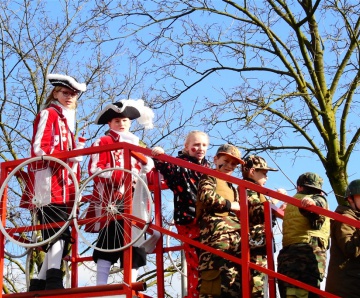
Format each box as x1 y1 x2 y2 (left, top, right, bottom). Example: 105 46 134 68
199 217 241 298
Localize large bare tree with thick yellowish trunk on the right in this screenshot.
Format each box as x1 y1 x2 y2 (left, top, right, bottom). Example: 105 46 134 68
99 0 360 202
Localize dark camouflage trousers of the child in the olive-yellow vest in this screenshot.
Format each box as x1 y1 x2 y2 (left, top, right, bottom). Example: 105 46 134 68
278 238 326 298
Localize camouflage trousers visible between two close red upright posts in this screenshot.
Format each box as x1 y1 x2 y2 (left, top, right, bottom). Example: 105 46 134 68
250 254 267 298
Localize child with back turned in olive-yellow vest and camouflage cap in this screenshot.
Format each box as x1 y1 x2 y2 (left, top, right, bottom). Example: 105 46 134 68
277 172 330 297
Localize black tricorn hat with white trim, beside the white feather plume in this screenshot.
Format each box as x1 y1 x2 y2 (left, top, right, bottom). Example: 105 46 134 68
95 102 140 124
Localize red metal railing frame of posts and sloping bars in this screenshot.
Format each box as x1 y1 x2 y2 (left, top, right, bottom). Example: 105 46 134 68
0 143 348 298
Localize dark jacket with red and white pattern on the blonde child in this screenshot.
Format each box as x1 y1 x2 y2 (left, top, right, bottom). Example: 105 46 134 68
154 151 210 225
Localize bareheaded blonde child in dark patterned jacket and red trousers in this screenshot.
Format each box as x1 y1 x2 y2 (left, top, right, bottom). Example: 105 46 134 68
152 130 209 298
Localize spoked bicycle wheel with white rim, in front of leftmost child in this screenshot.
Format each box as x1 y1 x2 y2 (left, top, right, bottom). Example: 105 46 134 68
0 155 79 248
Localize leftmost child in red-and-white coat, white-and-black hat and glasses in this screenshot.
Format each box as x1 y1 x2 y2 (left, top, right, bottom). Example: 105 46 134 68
26 74 86 291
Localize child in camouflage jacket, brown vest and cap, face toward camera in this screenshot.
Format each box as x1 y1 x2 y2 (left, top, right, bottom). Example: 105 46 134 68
196 144 244 298
